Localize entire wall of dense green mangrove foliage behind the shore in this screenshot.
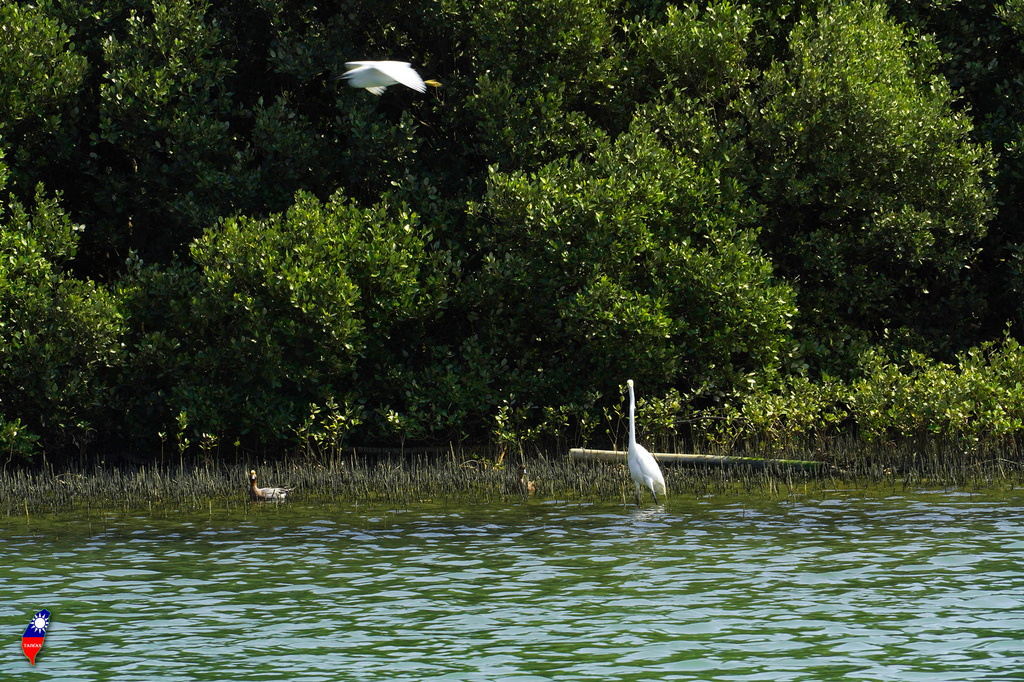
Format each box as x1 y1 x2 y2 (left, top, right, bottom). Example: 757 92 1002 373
0 0 1024 456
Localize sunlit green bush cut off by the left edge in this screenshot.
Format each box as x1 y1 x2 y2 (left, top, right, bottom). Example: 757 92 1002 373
0 159 124 454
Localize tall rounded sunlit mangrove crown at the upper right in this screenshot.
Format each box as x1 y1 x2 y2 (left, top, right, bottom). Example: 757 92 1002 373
750 5 992 364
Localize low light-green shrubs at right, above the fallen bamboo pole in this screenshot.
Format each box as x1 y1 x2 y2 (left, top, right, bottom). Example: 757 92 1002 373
713 339 1024 452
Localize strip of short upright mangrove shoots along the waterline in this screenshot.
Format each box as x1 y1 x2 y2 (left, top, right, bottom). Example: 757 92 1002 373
0 443 1024 516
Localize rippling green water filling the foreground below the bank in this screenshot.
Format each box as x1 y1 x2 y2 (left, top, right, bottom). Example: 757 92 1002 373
0 493 1024 681
